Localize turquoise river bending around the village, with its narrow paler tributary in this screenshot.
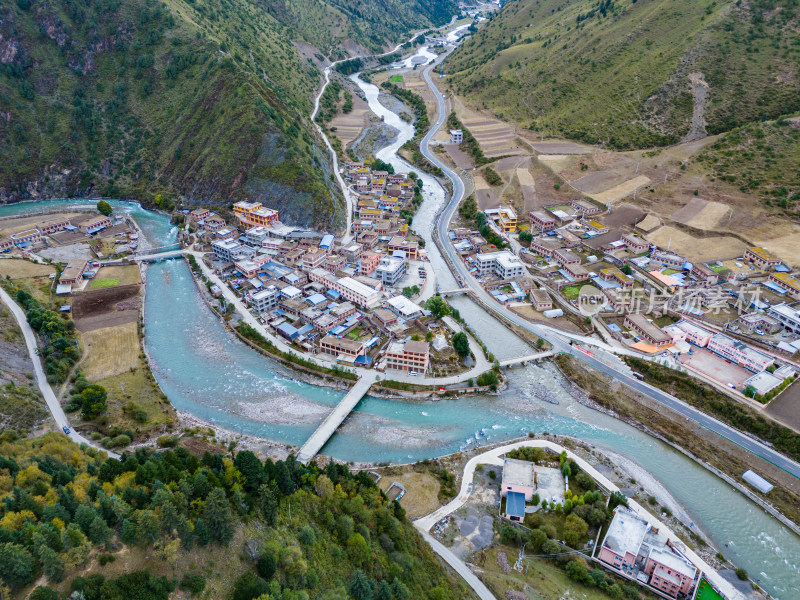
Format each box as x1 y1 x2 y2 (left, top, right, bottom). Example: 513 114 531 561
0 118 800 600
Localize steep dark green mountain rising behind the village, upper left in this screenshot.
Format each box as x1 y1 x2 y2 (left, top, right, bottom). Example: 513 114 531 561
0 0 457 226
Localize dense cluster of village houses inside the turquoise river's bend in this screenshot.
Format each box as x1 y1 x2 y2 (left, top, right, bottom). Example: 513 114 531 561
194 200 430 373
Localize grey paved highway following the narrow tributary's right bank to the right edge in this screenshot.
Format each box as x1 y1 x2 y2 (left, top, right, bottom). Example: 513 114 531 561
420 50 800 479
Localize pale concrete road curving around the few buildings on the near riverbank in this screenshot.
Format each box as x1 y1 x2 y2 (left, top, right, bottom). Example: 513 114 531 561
414 440 745 600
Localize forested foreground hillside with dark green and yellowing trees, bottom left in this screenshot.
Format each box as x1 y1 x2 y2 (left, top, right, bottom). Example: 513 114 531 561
0 431 469 600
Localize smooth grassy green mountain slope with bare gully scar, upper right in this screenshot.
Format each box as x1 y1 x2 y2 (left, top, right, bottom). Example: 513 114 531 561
445 0 800 149
